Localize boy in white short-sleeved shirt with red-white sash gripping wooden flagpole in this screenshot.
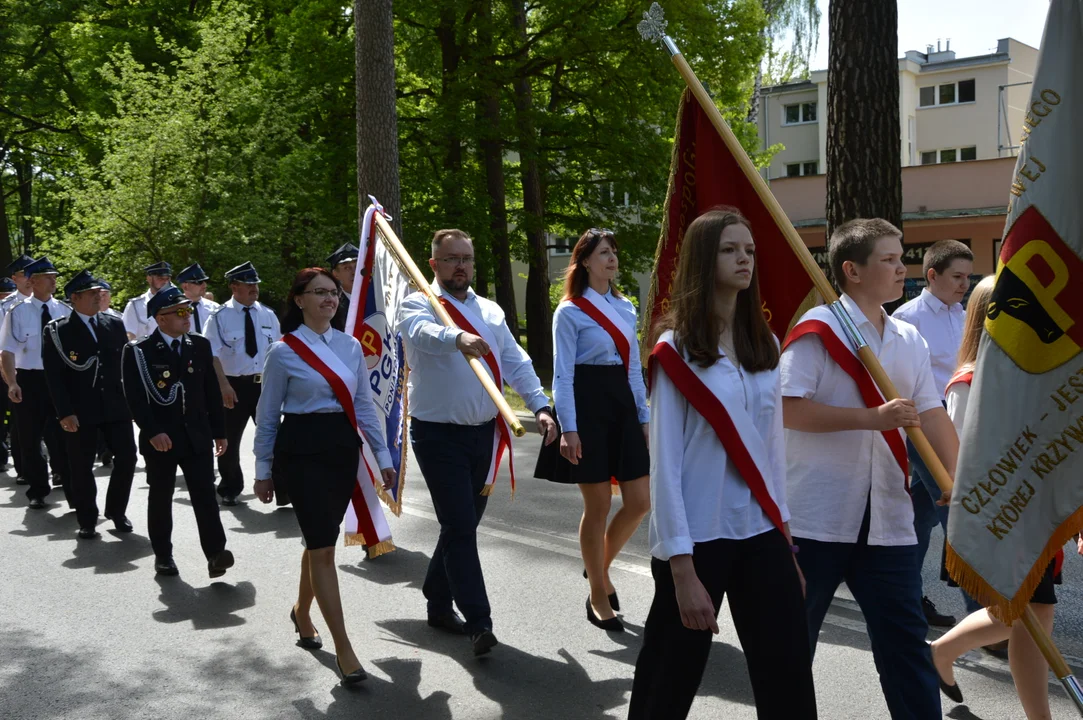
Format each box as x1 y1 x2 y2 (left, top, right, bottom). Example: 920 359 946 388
781 219 958 719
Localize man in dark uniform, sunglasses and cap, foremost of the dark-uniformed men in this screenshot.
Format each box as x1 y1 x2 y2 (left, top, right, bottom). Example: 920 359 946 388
121 285 233 577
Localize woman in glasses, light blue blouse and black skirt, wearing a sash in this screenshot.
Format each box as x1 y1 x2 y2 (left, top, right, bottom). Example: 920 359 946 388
255 267 395 685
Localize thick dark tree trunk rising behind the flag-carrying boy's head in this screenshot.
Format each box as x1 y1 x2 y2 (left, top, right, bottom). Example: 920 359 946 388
827 0 902 237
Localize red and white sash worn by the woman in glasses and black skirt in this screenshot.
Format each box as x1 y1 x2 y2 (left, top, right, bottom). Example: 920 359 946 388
283 330 394 557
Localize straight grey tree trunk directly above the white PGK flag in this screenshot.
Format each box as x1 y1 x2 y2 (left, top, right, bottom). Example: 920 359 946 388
353 0 403 237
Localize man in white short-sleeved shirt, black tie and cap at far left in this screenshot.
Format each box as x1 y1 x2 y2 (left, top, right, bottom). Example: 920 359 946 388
0 258 71 510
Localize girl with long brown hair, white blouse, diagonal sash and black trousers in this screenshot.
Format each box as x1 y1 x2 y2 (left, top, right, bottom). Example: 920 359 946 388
628 208 817 720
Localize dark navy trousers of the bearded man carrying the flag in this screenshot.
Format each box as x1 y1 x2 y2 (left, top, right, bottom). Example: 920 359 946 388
410 420 495 633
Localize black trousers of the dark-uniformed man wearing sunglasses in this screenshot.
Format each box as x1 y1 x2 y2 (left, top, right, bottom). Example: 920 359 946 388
143 446 225 560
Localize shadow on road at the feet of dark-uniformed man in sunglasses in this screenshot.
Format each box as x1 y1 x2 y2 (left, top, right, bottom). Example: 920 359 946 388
152 575 256 630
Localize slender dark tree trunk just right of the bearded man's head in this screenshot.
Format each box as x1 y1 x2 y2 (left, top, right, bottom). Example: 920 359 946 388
478 0 519 339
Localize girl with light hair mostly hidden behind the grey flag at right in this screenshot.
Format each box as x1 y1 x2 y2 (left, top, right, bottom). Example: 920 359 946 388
932 276 1057 720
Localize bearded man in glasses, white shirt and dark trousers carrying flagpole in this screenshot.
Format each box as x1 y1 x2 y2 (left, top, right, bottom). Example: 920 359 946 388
396 230 557 655
